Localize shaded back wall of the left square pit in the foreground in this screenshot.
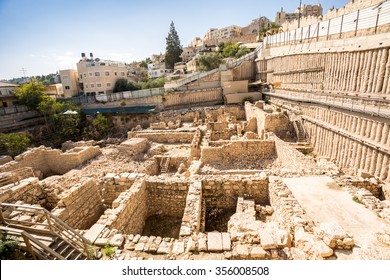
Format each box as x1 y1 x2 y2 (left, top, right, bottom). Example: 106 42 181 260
146 177 189 217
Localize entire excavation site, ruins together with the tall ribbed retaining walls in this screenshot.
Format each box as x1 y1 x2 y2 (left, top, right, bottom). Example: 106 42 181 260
0 0 390 260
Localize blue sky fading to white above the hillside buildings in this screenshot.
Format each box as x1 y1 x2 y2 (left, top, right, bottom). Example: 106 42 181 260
0 0 348 80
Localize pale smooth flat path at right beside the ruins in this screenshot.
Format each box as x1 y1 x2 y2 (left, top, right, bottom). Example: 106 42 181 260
283 176 390 260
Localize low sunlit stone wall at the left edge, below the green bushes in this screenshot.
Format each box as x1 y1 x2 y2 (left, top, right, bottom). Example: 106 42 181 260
0 146 101 177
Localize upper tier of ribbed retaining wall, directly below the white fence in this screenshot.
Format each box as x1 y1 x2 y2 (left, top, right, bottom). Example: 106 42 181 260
257 37 390 98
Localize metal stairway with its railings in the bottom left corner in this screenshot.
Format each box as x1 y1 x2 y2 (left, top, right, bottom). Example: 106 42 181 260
0 203 93 260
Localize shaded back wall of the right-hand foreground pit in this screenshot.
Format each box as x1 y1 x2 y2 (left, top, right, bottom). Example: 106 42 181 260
202 175 269 208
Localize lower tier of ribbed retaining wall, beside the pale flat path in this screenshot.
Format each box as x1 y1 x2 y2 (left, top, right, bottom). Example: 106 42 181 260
303 107 390 180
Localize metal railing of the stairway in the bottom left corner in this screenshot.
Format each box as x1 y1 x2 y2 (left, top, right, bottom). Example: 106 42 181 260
0 203 92 259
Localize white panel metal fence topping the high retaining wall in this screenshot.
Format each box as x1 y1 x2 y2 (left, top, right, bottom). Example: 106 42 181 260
264 0 390 46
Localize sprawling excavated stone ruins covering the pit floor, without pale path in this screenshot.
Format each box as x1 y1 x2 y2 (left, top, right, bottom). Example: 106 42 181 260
0 102 390 260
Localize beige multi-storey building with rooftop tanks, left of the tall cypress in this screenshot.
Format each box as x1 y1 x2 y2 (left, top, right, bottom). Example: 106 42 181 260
77 53 130 95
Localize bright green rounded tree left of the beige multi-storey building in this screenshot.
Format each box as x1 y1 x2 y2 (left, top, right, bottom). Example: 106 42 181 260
14 80 47 110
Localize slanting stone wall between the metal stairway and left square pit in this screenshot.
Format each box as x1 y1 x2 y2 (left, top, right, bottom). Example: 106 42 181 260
52 177 104 229
